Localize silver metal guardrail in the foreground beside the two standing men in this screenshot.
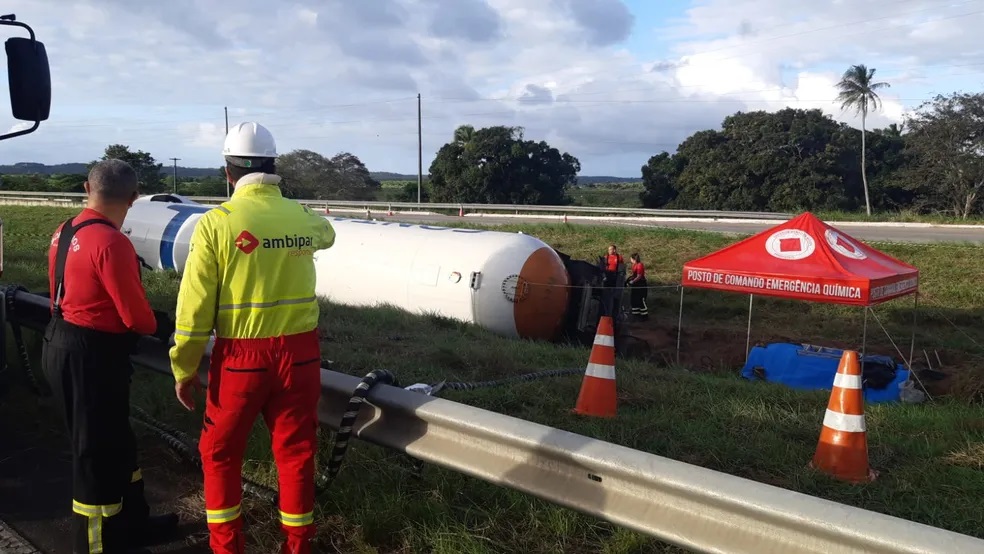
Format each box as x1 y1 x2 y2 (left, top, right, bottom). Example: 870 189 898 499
5 286 984 554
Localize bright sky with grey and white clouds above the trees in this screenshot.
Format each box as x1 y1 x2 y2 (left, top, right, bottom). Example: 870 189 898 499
0 0 984 177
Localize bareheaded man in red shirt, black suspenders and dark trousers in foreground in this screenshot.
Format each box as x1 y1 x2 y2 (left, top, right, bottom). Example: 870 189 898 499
41 159 178 553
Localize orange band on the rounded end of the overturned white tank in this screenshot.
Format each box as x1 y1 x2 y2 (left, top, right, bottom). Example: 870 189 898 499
513 247 570 340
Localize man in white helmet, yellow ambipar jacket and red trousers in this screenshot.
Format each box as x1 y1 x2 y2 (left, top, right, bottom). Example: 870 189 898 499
171 123 335 554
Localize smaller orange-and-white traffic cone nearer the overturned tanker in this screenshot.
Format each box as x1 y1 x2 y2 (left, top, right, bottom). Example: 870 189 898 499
573 316 618 417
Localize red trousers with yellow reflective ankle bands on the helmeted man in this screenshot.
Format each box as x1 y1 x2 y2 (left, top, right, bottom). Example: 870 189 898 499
199 330 321 554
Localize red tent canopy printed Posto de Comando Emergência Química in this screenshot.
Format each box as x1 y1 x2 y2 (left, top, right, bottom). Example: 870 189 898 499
682 212 919 306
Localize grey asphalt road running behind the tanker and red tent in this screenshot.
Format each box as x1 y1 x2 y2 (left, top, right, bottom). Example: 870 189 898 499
348 211 984 244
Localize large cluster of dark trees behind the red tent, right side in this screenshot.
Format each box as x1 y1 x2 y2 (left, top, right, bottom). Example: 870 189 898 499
642 89 984 218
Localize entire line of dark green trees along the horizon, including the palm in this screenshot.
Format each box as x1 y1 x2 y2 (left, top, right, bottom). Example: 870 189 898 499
3 65 984 213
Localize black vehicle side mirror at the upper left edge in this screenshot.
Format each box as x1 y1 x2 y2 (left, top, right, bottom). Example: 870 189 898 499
0 14 51 140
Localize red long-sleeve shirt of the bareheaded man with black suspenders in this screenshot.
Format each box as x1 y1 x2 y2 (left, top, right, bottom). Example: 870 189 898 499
48 208 157 335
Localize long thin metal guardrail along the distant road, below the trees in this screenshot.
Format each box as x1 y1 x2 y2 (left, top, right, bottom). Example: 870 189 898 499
0 190 793 221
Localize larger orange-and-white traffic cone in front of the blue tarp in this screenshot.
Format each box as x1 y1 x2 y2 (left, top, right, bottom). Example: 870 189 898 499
810 350 878 483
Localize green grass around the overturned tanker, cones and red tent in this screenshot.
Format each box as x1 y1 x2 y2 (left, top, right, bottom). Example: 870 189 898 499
2 206 984 554
